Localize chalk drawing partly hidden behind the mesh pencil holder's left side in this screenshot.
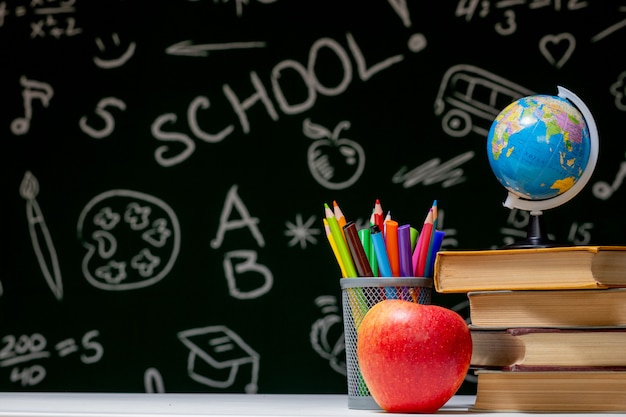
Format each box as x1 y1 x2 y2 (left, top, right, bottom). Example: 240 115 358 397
309 295 346 375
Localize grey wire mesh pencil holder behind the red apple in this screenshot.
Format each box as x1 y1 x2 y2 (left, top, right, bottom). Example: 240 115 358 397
339 278 433 410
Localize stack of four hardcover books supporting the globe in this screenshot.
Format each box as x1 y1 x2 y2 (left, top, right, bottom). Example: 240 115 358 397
434 246 626 412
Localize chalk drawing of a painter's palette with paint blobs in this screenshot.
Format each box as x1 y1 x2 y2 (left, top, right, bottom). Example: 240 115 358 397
78 190 180 291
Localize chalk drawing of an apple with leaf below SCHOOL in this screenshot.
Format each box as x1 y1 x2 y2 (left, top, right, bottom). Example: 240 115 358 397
302 119 365 190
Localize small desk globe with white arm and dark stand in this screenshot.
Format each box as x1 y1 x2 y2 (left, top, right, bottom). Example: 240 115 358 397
487 87 599 248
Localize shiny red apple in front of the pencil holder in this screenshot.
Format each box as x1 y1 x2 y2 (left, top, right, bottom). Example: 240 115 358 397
357 300 472 413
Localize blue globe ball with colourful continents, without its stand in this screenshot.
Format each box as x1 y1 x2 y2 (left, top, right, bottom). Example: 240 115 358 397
487 95 591 200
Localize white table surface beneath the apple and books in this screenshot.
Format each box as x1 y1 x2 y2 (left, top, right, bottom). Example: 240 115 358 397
0 392 606 417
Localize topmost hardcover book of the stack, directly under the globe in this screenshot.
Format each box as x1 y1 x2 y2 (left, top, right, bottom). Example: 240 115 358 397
434 246 626 293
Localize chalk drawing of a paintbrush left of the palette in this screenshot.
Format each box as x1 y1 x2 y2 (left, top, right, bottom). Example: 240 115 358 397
20 171 63 300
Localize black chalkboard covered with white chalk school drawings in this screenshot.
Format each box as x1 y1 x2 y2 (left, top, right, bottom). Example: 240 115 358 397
0 0 626 393
